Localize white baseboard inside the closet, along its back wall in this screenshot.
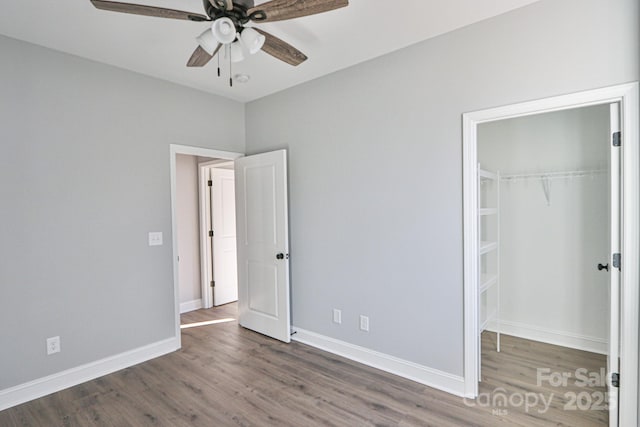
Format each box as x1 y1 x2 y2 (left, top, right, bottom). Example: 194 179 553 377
487 320 608 354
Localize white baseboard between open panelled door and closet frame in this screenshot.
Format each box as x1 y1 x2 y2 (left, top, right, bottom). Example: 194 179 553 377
291 326 464 396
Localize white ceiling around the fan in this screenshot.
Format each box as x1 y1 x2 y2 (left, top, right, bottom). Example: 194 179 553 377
0 0 538 101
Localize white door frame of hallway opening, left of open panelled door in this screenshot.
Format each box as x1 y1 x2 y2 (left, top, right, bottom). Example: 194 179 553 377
169 144 244 347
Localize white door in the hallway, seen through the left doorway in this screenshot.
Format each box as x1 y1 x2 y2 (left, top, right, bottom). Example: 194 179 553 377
211 168 238 306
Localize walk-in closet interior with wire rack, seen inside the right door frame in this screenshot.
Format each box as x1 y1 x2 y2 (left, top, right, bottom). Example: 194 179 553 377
478 105 611 419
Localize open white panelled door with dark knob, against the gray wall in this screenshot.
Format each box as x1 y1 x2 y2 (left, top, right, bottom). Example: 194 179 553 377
235 150 291 342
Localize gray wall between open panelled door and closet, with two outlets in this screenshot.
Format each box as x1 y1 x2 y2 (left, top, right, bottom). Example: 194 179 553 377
246 0 639 375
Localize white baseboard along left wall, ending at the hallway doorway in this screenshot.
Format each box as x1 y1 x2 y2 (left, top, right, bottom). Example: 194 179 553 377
0 337 180 411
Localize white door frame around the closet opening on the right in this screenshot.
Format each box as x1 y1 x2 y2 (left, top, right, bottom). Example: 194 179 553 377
462 82 640 426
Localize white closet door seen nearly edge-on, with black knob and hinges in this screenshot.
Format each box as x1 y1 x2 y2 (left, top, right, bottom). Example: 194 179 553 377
598 103 621 427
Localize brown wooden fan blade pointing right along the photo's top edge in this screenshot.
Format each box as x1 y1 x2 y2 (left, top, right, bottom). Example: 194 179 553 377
247 0 349 22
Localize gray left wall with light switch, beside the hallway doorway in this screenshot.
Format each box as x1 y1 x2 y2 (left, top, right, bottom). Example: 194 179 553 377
0 37 245 389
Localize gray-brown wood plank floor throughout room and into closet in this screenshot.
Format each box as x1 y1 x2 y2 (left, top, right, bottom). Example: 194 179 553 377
0 304 607 427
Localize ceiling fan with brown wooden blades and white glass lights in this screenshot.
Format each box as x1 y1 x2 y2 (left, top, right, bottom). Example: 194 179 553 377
91 0 349 75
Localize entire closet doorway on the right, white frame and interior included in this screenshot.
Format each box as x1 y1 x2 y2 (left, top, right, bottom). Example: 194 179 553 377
463 84 638 425
